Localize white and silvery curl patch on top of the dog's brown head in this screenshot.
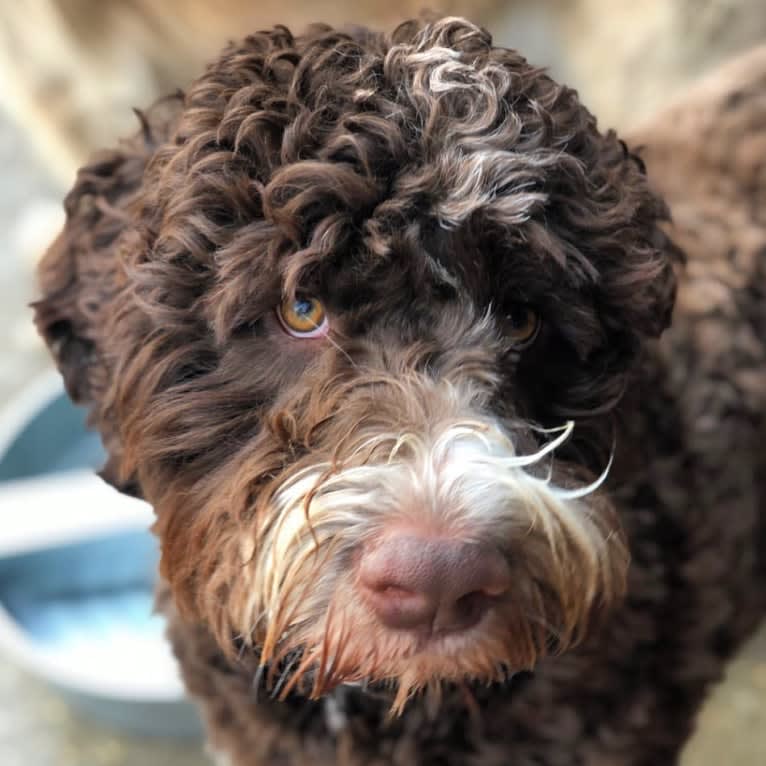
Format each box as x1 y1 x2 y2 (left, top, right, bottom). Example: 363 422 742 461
385 18 560 228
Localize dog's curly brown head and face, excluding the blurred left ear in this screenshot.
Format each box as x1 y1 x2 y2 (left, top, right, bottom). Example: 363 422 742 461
34 19 674 709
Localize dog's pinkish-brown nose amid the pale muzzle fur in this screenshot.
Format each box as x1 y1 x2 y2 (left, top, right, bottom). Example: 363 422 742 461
359 535 511 633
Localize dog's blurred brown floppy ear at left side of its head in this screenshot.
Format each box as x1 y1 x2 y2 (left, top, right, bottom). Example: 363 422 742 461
32 93 183 490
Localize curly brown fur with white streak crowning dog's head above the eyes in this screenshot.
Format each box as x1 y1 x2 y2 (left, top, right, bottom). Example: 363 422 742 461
160 19 662 352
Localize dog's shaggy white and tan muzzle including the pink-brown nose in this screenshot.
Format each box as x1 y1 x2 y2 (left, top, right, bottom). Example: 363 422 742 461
234 380 628 706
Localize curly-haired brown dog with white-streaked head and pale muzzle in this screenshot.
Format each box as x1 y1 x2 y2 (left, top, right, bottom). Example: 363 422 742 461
36 19 766 766
